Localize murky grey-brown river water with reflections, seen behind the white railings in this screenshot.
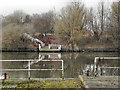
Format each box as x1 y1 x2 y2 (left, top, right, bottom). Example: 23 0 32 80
2 52 118 78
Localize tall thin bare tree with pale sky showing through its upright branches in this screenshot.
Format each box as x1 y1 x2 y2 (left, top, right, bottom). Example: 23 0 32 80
87 2 110 41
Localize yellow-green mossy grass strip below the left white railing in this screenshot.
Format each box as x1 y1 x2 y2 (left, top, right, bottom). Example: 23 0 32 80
2 79 83 89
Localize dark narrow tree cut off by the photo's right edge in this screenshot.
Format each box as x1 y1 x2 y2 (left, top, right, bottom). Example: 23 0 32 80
109 2 120 47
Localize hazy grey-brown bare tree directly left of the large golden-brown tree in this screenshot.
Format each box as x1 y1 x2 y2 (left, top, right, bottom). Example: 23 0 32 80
33 11 54 34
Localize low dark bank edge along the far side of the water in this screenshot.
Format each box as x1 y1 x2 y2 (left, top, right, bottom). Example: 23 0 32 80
0 48 120 52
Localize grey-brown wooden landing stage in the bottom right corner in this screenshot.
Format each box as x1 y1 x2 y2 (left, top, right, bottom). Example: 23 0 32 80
79 75 120 88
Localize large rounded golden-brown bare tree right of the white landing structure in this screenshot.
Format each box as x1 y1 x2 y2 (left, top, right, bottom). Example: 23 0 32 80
54 2 87 50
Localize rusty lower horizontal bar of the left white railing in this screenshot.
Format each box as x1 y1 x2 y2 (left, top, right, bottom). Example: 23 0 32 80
0 69 62 71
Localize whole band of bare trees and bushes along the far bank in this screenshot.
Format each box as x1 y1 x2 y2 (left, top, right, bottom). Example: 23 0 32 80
2 1 119 50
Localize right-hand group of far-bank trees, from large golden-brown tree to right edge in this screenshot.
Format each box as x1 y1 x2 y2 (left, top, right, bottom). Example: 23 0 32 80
54 2 120 50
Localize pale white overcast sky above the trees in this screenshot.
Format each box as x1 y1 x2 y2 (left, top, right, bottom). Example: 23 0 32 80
0 0 118 15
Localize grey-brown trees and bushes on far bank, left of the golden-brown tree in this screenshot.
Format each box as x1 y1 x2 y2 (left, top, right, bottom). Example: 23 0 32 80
2 10 55 50
